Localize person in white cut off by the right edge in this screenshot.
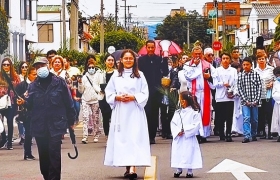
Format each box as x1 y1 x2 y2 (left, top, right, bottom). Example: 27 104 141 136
270 66 280 142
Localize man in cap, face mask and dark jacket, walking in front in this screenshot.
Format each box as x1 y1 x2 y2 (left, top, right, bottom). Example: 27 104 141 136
17 57 76 180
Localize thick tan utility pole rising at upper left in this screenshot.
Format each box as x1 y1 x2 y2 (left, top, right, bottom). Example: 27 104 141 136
70 0 79 50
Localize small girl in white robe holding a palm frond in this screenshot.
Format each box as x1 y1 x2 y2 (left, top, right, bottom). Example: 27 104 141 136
170 91 203 178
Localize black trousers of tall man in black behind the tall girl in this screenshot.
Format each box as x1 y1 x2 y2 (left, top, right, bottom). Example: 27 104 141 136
145 94 160 140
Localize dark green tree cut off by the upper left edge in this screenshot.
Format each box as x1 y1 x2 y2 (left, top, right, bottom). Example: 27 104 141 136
0 6 9 54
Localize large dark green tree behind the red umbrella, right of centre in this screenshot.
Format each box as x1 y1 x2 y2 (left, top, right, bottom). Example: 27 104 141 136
155 10 211 47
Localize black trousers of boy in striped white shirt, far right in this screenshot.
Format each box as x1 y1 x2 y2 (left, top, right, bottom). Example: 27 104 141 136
258 99 273 135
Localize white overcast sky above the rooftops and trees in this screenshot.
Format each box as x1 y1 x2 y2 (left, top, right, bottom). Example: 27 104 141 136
38 0 212 17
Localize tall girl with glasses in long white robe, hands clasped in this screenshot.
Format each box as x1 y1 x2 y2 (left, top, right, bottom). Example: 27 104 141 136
104 50 151 179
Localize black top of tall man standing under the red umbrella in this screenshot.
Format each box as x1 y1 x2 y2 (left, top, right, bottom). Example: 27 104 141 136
138 55 169 96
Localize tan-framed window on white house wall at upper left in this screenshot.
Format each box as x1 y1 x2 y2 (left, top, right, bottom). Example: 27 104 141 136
37 24 53 43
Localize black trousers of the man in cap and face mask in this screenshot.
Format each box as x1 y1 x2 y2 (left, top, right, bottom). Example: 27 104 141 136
35 135 61 180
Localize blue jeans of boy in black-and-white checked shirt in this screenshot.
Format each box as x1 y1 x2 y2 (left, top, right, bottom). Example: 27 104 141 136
242 106 258 139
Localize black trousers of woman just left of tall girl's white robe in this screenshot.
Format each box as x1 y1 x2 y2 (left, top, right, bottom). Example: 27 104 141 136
99 98 112 136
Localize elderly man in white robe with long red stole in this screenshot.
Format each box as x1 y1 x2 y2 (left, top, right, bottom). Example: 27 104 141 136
184 46 216 142
